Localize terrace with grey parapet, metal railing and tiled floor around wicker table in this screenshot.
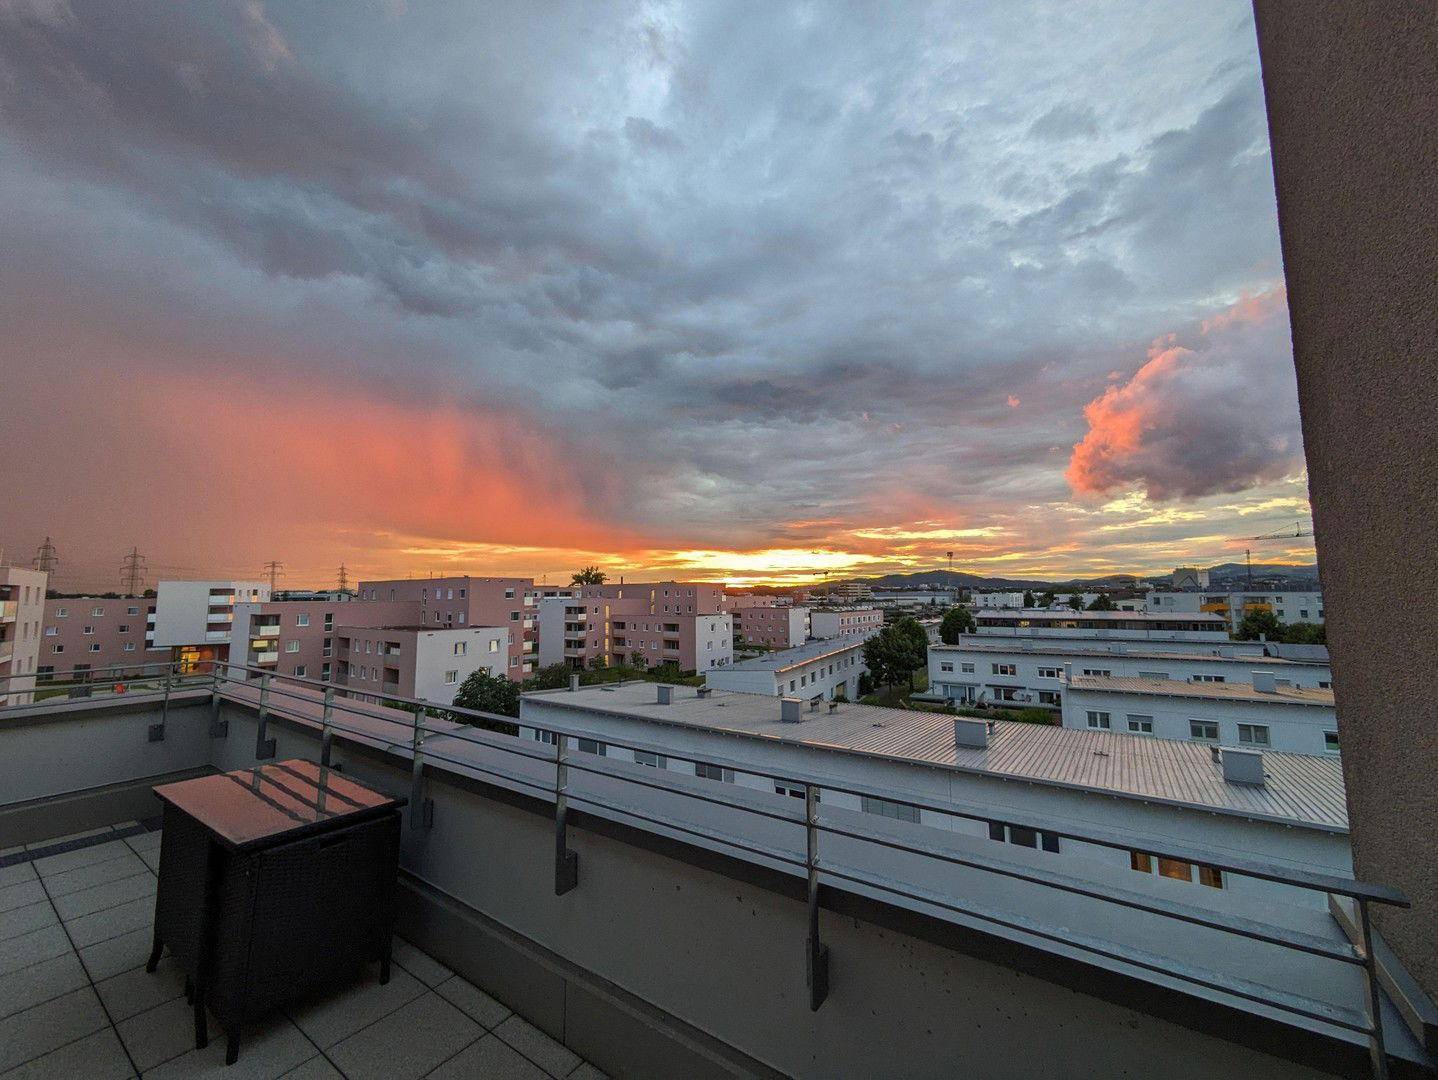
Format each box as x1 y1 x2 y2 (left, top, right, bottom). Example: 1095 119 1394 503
0 666 1432 1077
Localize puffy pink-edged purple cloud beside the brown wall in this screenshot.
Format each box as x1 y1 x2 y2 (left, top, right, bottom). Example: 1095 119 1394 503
1066 292 1303 500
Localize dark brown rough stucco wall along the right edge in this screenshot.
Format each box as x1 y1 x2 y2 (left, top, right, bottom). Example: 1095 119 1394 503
1254 0 1438 994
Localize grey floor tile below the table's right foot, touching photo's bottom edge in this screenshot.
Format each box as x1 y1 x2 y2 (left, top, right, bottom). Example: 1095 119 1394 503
325 992 485 1080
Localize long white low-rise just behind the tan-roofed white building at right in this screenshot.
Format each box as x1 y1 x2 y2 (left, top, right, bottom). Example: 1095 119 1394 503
929 634 1333 709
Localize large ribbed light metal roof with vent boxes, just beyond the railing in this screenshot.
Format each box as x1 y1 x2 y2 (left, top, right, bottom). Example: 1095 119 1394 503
525 682 1347 833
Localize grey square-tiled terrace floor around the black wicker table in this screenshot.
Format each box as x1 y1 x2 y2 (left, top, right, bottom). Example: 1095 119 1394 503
0 823 603 1080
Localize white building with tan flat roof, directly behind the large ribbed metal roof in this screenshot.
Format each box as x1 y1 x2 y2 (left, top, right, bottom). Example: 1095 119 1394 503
1063 664 1339 762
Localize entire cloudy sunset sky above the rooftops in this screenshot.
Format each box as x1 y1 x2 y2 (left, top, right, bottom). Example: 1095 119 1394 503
0 0 1313 588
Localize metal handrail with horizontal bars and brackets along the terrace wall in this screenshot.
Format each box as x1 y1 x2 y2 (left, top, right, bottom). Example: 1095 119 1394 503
0 660 1409 1076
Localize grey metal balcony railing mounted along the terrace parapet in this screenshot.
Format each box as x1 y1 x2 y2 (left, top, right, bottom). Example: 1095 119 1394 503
0 660 1409 1077
